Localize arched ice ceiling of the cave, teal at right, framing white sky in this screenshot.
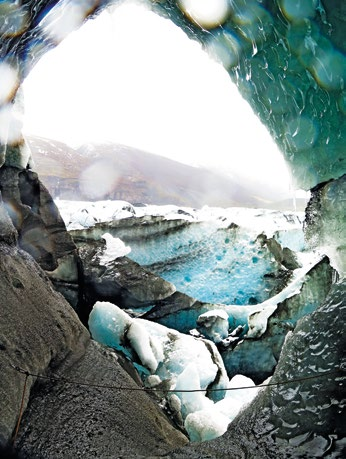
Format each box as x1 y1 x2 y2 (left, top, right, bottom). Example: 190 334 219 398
0 0 346 190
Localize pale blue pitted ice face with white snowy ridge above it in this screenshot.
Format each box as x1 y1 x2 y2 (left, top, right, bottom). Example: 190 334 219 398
57 200 304 305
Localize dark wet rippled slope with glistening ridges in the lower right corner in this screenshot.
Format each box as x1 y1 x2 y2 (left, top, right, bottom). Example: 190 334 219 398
165 281 346 459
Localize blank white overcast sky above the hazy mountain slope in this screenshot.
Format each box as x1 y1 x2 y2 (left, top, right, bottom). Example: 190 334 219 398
23 2 290 198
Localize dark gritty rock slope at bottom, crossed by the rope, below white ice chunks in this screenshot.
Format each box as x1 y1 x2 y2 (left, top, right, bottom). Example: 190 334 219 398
17 341 187 459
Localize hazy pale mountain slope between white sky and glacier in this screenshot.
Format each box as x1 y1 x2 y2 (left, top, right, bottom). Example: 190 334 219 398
27 136 306 208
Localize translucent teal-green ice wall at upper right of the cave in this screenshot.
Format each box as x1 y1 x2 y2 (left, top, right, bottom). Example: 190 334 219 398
153 0 346 189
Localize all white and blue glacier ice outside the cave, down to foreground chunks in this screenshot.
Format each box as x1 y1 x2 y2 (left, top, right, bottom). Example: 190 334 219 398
58 202 330 441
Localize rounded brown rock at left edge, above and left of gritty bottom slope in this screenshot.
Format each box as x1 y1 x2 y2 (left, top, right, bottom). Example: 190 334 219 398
0 244 89 444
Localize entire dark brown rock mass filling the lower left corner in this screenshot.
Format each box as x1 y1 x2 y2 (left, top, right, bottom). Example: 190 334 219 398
0 244 187 459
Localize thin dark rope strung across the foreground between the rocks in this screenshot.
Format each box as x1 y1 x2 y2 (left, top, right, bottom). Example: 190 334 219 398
10 364 345 398
